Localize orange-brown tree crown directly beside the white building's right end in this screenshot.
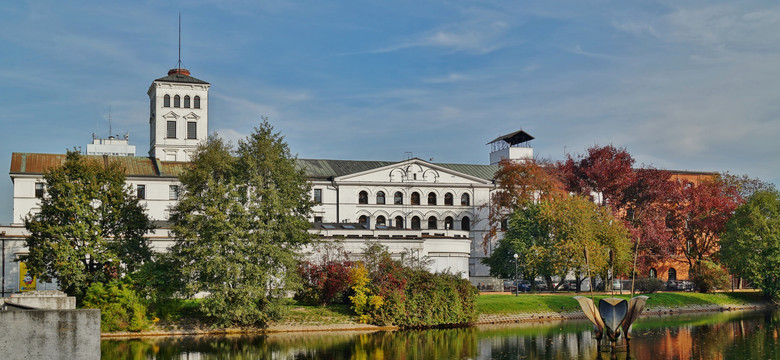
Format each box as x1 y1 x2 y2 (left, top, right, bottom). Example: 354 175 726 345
482 159 565 249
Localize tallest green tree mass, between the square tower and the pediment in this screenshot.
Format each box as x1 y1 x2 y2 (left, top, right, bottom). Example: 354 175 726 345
171 120 311 326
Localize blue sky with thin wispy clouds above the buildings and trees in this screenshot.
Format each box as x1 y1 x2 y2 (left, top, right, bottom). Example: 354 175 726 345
0 0 780 224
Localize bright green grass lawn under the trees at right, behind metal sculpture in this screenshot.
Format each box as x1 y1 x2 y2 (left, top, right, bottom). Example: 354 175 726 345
477 292 763 314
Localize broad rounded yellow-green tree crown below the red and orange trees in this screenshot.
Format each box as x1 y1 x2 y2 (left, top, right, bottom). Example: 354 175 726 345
483 196 632 286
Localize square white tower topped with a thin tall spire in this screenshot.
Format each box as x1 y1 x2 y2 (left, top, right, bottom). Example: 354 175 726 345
147 18 211 161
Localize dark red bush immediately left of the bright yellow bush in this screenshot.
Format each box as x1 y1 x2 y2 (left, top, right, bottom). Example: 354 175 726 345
295 243 354 305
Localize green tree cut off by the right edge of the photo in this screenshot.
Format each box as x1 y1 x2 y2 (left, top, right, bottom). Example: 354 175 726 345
719 190 780 302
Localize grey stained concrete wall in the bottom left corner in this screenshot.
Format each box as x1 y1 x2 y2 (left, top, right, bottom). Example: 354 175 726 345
0 309 100 360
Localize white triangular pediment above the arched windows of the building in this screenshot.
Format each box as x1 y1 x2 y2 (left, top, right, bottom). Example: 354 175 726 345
335 159 490 184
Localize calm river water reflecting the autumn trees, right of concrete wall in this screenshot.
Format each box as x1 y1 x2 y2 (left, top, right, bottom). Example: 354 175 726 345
101 312 780 360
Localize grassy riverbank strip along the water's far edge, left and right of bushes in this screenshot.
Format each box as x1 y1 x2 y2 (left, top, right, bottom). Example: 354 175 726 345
102 291 772 338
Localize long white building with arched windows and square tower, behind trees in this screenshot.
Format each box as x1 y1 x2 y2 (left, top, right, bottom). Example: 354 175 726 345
0 69 533 292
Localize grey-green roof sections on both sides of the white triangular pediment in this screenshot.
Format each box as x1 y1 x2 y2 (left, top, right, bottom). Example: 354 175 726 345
297 159 498 181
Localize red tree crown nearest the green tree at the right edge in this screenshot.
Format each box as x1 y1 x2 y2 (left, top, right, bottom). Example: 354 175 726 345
667 180 742 269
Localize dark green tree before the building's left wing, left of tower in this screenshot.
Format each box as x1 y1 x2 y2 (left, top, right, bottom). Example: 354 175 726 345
21 151 152 299
